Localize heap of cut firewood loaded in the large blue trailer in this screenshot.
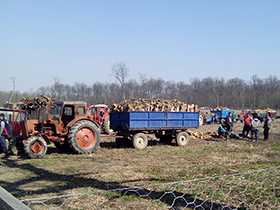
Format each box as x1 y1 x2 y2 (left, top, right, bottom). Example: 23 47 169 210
110 98 198 112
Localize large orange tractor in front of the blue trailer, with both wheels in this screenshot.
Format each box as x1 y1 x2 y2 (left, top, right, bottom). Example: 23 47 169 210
11 102 100 158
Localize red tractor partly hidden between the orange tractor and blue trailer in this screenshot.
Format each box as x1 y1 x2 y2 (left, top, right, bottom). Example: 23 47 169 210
89 104 113 135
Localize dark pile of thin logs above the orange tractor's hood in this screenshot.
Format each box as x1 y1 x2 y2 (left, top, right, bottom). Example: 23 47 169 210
19 95 55 111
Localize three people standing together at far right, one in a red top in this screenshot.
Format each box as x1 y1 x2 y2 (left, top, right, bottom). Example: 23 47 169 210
242 112 272 141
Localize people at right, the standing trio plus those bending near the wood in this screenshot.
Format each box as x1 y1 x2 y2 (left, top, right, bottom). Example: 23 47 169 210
218 112 272 141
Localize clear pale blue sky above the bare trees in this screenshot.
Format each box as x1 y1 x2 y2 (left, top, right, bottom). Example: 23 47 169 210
0 0 280 92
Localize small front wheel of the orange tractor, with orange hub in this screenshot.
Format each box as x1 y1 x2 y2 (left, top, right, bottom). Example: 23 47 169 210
24 136 47 158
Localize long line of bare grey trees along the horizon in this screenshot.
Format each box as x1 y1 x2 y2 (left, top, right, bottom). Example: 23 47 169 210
0 72 280 109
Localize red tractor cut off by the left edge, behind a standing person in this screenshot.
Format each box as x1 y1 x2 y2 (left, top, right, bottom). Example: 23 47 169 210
0 109 28 154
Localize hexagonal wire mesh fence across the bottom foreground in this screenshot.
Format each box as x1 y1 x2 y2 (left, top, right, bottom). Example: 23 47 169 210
21 167 280 210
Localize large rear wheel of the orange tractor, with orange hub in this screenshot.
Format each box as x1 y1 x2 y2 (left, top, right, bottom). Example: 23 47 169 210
68 120 100 154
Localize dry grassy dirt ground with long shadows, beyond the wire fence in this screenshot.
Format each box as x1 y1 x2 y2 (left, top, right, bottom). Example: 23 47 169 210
0 119 280 199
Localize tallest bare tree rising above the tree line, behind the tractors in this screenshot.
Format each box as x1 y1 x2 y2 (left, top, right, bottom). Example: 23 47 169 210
110 62 129 100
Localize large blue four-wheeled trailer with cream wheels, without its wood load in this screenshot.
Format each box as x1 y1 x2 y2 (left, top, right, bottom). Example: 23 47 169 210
110 111 199 149
